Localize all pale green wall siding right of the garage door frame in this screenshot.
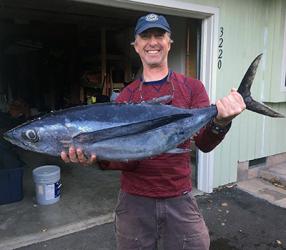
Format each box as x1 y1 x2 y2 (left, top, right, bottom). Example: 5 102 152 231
179 0 286 187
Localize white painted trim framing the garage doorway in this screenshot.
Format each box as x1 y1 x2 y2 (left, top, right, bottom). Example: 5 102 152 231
73 0 219 193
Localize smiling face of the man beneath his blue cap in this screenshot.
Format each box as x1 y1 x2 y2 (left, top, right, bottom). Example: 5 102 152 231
134 28 171 67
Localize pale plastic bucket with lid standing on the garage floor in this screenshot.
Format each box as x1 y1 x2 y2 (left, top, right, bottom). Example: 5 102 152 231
33 165 61 205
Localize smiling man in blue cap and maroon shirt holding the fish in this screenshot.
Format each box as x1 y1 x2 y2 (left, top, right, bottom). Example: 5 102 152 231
61 14 245 250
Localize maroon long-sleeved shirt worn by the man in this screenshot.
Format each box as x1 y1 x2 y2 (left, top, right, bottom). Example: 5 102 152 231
100 72 229 198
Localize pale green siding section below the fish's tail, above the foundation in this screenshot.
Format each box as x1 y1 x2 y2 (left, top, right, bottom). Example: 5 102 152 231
214 103 286 187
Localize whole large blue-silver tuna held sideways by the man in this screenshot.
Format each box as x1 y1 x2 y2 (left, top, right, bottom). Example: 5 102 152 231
4 55 283 161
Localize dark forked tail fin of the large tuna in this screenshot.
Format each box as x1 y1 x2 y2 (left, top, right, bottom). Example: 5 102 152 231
237 54 285 117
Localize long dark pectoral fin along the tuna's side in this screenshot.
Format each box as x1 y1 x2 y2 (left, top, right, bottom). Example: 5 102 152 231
73 113 192 143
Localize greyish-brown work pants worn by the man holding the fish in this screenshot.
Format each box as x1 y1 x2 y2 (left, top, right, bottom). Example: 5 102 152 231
115 191 210 250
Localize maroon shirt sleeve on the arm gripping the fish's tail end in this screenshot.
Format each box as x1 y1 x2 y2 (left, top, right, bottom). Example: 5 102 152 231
191 80 231 152
